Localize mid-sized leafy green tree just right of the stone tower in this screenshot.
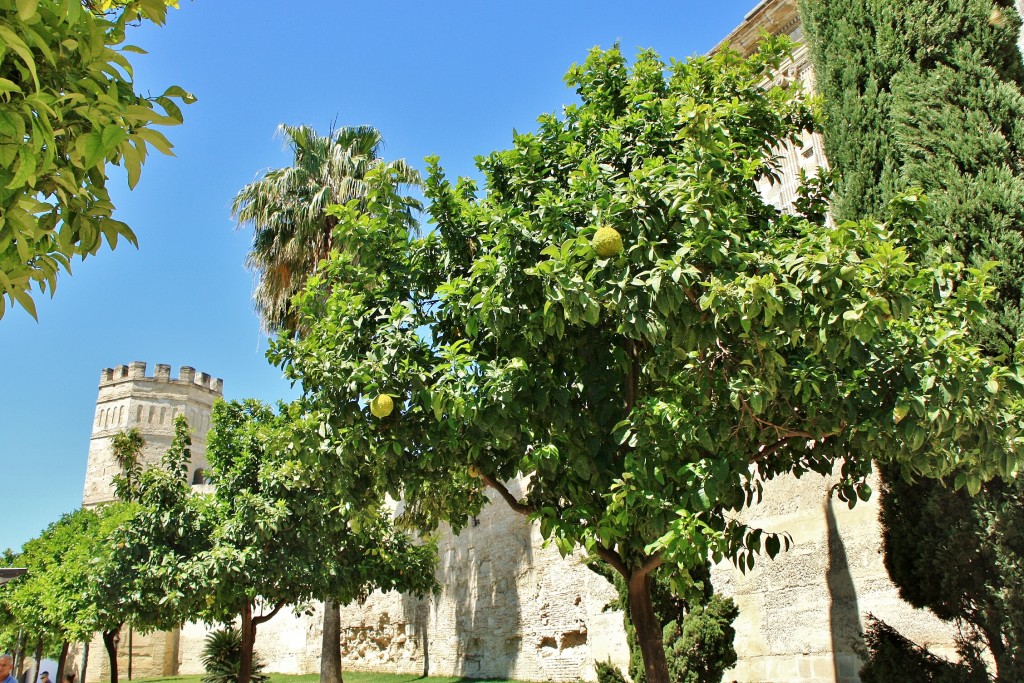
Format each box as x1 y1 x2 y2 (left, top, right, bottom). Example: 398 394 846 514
193 400 436 683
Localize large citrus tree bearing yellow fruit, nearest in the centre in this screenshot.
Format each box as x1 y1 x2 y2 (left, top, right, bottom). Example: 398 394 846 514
270 40 1022 683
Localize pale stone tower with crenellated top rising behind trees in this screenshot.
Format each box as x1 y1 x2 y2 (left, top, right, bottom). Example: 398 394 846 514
82 361 224 506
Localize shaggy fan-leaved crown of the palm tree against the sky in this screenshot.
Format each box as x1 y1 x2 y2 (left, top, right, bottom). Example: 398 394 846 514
231 124 421 333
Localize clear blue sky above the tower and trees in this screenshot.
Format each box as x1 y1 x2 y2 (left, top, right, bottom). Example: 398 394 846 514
0 0 756 549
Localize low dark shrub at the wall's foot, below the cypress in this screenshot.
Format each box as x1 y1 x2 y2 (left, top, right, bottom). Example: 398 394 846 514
860 615 989 683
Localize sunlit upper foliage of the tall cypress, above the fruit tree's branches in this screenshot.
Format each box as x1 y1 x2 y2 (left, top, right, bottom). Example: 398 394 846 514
801 0 1024 349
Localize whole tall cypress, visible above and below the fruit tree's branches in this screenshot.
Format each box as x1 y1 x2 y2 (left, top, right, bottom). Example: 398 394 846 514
800 0 1024 681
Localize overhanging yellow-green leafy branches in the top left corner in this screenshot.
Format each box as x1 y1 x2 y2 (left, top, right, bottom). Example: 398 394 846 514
0 0 196 317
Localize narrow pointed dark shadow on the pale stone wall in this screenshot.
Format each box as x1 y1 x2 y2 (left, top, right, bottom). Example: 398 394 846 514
825 496 864 683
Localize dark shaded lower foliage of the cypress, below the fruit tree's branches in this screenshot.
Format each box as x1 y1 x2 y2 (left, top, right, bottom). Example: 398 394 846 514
881 462 1024 681
